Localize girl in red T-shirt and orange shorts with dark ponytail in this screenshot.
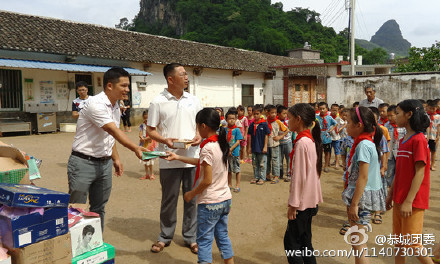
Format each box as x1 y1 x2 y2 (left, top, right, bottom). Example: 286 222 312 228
386 100 433 263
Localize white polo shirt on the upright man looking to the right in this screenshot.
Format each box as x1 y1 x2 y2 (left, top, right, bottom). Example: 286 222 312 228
147 88 202 169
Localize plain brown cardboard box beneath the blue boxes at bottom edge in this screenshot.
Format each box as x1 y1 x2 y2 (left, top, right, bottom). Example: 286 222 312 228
9 233 72 264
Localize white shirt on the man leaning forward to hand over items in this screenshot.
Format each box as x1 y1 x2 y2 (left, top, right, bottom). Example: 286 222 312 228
72 92 121 158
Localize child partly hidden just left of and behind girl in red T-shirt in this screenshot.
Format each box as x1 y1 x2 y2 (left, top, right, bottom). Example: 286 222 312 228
385 105 406 187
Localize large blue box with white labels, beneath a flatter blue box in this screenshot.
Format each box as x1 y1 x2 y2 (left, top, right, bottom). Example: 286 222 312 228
0 207 69 249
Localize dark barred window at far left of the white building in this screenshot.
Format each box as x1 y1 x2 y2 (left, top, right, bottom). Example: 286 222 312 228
0 70 23 111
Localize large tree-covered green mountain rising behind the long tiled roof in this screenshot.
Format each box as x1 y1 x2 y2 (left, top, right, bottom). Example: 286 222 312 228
116 0 388 63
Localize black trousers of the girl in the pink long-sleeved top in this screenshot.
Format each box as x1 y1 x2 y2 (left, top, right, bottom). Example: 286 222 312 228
284 206 318 264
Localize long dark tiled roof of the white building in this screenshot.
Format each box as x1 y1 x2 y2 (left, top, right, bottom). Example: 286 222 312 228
0 11 304 72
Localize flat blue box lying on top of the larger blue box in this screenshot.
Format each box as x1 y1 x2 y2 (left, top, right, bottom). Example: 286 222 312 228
0 183 70 207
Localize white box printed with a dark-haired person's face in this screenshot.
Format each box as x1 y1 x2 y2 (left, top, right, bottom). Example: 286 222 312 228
69 217 104 257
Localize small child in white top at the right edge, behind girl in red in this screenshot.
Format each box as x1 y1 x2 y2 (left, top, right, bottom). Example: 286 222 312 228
426 100 440 171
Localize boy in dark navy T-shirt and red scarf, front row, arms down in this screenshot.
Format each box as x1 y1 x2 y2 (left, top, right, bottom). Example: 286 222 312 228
247 105 270 185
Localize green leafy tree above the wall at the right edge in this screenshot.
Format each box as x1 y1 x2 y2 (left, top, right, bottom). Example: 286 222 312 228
396 41 440 72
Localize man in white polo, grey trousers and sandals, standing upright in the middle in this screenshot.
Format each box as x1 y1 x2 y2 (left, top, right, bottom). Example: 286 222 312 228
147 63 202 254
